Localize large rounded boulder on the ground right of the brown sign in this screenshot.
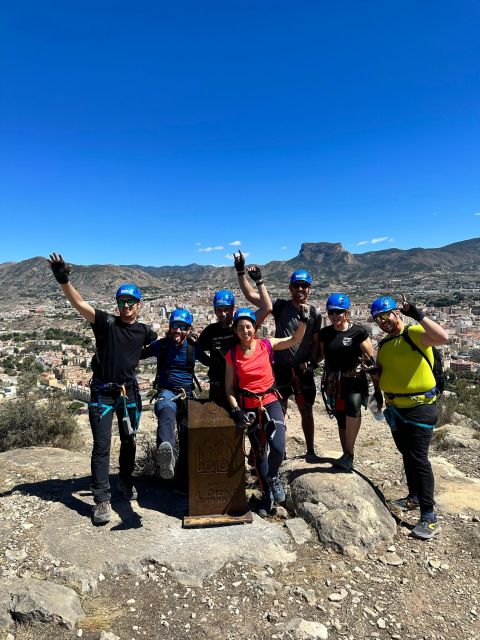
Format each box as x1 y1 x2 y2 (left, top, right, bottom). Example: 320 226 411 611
287 460 396 555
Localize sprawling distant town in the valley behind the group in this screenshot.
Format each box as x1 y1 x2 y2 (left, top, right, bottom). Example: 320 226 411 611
0 283 480 402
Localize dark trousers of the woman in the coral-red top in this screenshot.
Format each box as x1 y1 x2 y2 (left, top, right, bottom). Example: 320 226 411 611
249 400 285 495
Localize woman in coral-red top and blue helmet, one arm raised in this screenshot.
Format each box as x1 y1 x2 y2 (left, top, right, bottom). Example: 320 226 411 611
225 307 308 516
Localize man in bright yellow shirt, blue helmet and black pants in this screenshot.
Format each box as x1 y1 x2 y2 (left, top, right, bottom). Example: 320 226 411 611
370 296 448 539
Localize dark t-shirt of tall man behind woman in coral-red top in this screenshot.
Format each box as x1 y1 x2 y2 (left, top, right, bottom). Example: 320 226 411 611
272 298 322 367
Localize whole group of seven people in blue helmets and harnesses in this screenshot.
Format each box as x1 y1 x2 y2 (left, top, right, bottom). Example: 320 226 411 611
49 252 448 538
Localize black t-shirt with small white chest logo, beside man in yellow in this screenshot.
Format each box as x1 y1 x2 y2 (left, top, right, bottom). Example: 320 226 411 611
318 324 368 371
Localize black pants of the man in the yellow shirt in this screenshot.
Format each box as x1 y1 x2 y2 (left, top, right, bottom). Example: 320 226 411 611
390 405 438 513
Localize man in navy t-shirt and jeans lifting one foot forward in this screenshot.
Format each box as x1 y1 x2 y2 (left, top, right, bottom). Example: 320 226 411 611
141 309 210 481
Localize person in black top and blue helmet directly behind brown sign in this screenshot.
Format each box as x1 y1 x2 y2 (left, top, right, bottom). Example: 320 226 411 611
198 286 271 411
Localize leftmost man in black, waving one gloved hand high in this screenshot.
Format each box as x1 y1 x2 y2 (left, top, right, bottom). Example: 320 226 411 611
48 253 157 524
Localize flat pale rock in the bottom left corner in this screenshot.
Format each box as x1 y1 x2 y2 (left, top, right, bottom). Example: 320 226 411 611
0 578 85 629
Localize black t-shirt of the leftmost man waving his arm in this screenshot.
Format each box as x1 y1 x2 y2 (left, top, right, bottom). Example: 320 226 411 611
91 309 157 384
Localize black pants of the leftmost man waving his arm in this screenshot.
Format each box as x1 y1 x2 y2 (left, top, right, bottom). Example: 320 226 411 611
88 384 142 504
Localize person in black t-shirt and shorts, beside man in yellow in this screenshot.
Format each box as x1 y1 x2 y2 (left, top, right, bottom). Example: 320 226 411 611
318 293 381 472
